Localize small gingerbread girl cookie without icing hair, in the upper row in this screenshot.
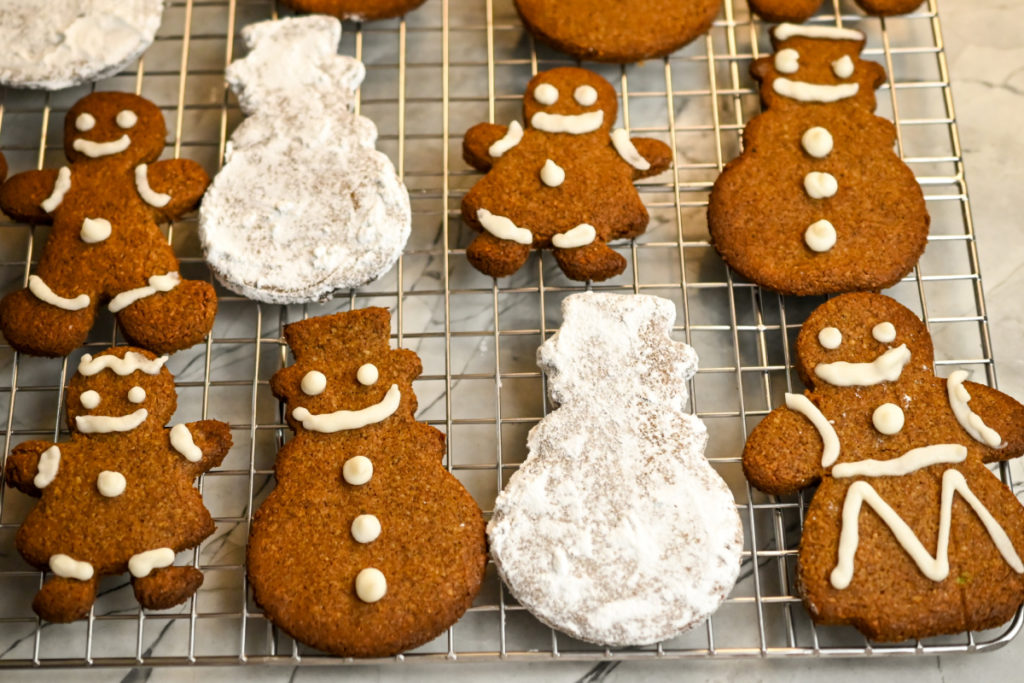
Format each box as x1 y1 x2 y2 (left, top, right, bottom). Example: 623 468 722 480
462 67 672 281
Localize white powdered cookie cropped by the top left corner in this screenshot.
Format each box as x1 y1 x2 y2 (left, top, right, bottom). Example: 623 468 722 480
0 0 164 90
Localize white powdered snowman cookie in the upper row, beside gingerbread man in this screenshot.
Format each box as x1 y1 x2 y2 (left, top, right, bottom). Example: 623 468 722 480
200 15 412 303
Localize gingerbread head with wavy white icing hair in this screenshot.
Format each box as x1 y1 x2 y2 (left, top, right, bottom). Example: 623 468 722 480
68 346 177 435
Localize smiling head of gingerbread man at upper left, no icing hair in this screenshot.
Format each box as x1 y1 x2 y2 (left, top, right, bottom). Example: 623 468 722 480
65 92 167 165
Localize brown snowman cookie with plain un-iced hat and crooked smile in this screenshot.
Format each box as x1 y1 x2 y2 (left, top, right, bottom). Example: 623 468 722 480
247 308 486 657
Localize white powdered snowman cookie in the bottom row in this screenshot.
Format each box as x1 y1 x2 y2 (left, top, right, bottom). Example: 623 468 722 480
487 292 742 646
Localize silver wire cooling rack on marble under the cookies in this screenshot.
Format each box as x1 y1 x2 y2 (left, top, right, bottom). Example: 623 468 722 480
0 0 1021 667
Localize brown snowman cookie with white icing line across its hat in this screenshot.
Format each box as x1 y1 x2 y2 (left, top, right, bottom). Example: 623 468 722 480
708 24 929 295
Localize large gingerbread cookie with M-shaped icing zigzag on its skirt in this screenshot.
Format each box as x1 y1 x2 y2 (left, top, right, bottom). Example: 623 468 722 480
743 294 1024 641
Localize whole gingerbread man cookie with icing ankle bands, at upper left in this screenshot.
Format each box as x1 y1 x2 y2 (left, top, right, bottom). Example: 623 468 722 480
0 92 217 356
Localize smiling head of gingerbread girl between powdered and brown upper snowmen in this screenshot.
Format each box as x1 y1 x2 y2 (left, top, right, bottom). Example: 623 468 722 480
523 67 618 135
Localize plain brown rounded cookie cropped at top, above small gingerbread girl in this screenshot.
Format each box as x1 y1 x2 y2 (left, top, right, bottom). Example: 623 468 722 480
515 0 722 62
